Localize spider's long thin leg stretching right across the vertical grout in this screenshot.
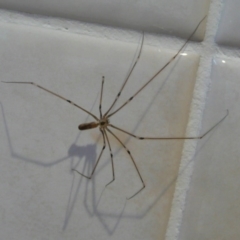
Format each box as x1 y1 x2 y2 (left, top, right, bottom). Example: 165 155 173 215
108 110 229 140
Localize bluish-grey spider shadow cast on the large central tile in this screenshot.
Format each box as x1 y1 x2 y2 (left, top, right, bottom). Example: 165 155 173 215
1 45 204 235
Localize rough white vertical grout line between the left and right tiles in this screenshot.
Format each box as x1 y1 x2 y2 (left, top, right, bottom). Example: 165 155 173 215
166 0 226 240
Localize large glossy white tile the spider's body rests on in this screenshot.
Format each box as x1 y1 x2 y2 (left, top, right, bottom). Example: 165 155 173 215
0 23 199 240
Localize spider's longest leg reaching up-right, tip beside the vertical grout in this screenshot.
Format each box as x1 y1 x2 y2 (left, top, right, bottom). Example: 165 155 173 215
107 16 206 118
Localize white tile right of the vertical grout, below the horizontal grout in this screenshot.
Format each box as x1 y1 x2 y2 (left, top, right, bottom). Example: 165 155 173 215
179 58 240 240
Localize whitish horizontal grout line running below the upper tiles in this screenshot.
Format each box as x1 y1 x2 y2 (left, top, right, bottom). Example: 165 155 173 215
0 7 240 58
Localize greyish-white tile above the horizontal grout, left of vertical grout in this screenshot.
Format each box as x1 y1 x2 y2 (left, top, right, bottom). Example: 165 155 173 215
0 0 209 39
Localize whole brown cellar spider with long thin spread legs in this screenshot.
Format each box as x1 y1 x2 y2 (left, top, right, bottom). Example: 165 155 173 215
3 16 228 200
